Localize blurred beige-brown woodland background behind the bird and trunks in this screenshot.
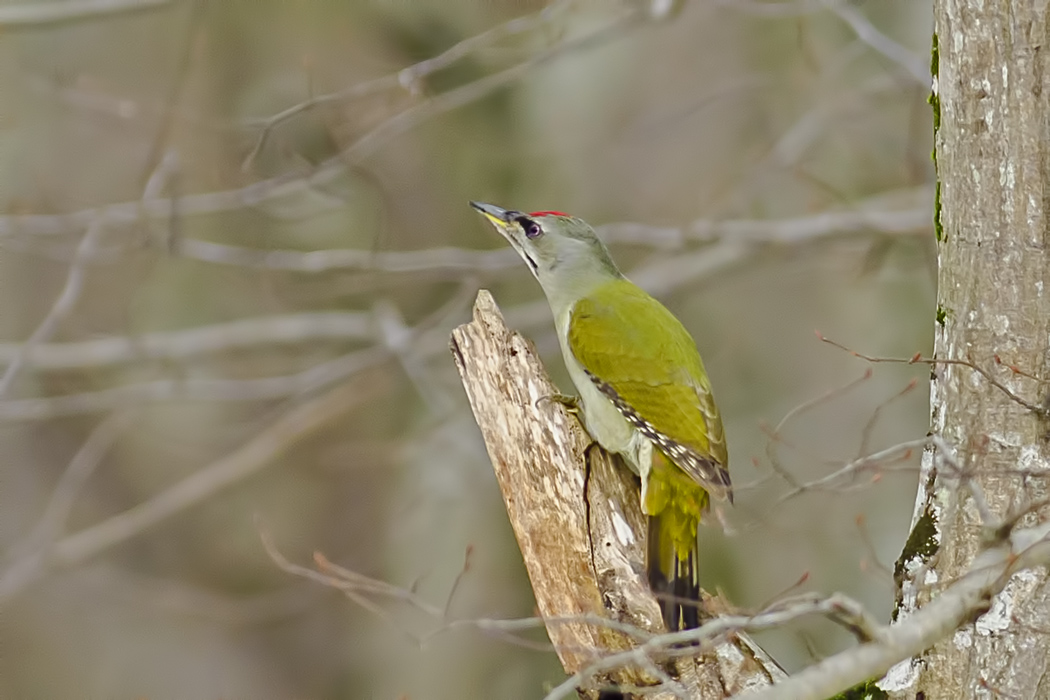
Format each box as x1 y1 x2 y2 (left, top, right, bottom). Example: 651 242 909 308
0 0 936 700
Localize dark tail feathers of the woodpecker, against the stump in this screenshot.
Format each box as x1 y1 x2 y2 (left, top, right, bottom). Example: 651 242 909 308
646 515 700 632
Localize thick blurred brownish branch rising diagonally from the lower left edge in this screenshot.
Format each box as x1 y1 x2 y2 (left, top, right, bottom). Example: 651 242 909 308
0 371 378 607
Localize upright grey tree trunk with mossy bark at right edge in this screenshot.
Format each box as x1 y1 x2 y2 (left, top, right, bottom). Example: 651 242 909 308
882 0 1050 700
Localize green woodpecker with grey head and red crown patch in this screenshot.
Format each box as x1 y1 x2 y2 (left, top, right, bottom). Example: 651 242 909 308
470 201 733 631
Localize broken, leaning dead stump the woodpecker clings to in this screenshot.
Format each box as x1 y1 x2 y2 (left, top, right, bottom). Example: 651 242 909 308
452 291 781 700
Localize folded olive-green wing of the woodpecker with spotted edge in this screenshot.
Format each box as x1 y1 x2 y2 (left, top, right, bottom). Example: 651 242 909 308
569 279 732 497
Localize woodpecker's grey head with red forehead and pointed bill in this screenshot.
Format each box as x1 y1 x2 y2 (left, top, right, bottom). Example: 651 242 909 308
470 201 621 296
